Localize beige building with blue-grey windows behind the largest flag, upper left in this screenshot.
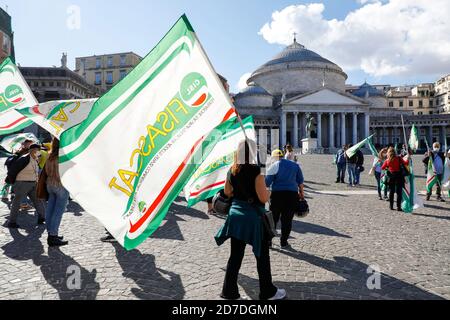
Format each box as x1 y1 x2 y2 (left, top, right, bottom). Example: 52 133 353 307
75 52 142 92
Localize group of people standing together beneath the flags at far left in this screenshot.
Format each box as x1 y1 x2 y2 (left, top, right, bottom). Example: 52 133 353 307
3 139 69 247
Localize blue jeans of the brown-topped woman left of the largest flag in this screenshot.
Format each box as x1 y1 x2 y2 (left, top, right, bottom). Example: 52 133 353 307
45 185 69 236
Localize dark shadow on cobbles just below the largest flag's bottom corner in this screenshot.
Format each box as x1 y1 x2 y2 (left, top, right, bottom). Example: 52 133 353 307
112 242 185 300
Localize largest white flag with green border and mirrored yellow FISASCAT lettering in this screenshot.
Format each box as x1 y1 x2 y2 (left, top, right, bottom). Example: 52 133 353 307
60 15 236 250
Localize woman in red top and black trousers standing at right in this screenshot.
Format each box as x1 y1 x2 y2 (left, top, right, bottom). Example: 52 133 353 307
381 147 409 211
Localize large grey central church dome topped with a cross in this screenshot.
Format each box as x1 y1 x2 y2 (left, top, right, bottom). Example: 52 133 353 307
247 39 347 95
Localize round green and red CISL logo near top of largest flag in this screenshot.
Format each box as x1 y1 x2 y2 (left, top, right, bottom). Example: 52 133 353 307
180 72 209 108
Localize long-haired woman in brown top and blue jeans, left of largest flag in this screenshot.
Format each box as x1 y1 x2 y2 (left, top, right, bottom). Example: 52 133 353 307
44 138 69 247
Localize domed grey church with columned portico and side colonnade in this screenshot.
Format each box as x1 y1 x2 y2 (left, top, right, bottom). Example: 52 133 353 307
234 39 450 153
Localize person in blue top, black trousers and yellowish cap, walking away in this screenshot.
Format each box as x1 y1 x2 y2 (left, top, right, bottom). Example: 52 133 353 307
266 150 305 249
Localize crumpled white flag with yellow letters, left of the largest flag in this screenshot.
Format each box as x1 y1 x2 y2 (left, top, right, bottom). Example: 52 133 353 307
17 99 97 139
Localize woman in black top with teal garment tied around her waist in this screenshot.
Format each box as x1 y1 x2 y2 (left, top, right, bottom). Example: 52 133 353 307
215 140 286 300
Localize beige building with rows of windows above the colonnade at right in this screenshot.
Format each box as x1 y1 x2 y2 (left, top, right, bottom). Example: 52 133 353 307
386 83 439 115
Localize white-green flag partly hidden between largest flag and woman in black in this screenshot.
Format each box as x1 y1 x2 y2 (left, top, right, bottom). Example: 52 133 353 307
184 117 256 206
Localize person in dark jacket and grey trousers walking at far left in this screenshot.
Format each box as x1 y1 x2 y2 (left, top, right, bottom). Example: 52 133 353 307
7 144 45 229
